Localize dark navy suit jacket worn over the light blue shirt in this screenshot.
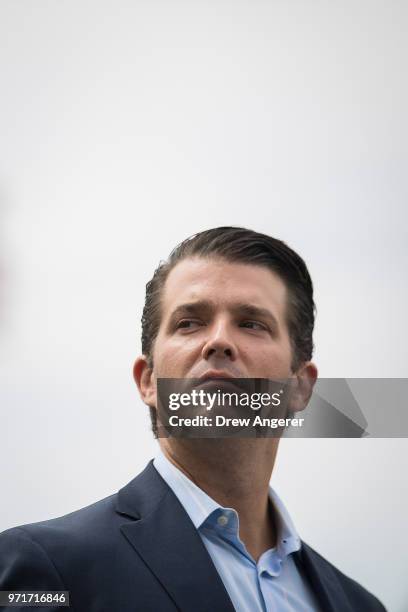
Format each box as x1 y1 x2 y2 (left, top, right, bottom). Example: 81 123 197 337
0 462 385 612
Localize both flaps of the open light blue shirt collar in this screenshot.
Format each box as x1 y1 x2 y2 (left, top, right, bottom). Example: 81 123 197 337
153 449 301 556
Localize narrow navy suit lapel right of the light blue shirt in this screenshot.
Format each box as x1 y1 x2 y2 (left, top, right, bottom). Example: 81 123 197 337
294 542 353 612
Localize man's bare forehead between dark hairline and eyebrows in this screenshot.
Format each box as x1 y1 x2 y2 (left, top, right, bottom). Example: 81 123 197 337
162 258 287 322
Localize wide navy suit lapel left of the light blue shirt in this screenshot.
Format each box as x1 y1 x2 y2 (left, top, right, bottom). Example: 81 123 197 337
117 462 234 612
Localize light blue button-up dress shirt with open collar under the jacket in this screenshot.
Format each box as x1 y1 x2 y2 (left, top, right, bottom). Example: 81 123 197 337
153 451 320 612
